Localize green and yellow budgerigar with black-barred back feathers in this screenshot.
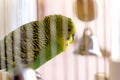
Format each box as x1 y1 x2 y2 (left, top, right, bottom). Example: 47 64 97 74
0 14 75 71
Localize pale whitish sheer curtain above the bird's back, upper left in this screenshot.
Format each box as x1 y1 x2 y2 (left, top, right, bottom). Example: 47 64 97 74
0 0 37 39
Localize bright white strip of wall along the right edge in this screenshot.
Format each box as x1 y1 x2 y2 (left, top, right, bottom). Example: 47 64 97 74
111 0 120 60
